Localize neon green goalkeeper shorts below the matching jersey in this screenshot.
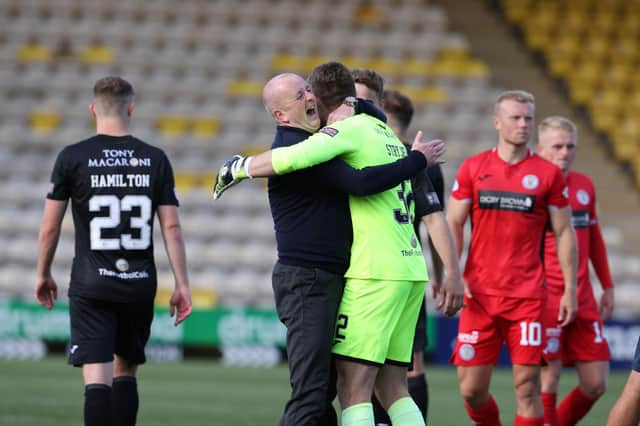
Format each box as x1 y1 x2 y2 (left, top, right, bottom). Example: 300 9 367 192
333 278 425 366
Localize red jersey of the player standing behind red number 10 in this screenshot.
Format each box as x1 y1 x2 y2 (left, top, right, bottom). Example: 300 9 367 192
544 171 613 311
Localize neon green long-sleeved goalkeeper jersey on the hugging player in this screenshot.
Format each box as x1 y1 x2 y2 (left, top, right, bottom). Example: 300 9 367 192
271 114 428 281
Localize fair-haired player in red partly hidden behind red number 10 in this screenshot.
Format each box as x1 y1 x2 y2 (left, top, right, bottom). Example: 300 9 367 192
538 116 613 426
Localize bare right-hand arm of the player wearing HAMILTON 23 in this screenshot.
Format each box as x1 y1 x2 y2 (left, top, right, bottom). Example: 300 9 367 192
158 205 192 325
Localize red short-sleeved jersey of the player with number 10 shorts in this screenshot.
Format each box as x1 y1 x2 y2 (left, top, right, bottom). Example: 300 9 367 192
451 148 568 299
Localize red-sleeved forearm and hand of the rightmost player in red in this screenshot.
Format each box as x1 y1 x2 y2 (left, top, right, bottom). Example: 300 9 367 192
589 215 615 321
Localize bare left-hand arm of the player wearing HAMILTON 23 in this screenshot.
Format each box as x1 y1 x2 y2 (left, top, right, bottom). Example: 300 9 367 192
35 199 67 309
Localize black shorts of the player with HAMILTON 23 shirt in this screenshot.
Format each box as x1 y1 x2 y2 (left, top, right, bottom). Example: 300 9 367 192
69 296 153 366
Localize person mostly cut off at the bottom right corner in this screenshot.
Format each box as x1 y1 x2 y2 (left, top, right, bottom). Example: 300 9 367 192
607 338 640 426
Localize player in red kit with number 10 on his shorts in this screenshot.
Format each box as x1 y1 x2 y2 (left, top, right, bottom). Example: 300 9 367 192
447 91 577 426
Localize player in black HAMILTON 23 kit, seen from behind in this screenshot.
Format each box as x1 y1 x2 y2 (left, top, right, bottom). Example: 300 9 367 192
35 77 191 426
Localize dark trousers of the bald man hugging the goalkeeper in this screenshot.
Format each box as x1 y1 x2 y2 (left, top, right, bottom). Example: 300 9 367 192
272 262 344 426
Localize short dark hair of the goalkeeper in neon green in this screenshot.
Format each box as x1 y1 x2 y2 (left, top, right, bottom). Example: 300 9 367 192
308 62 356 110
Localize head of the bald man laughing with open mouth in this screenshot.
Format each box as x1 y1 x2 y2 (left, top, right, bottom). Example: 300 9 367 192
262 73 320 133
